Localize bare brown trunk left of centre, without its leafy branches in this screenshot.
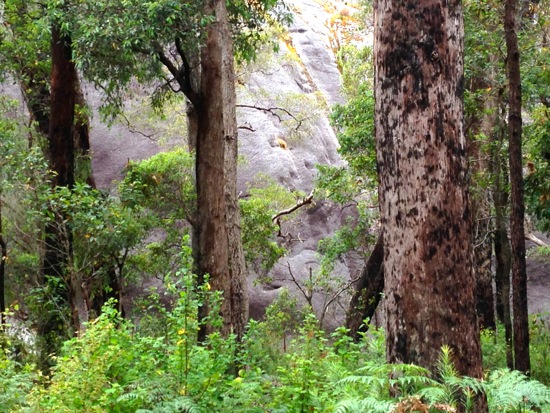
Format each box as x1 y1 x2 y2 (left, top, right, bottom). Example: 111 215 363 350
195 0 248 340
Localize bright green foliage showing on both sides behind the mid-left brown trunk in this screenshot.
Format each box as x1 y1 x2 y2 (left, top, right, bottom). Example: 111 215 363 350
119 152 296 273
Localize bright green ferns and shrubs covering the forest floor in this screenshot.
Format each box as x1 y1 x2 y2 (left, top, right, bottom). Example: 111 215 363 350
0 272 550 413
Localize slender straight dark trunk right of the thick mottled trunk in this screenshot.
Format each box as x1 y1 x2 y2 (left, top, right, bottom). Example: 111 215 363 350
504 0 530 373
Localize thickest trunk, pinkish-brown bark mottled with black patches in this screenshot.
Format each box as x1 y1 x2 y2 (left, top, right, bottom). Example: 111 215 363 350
374 0 486 400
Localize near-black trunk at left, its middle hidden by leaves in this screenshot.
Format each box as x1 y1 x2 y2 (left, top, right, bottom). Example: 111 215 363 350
38 24 79 372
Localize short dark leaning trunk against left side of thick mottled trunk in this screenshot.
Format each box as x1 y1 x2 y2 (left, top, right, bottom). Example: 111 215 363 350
346 235 384 341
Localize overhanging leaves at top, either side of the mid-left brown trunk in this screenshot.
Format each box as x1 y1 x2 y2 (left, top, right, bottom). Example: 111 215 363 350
63 0 290 117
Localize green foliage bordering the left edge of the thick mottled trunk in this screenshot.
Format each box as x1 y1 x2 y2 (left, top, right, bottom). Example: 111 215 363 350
316 45 378 282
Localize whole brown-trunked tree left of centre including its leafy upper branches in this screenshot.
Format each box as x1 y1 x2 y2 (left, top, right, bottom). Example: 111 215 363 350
65 0 287 338
